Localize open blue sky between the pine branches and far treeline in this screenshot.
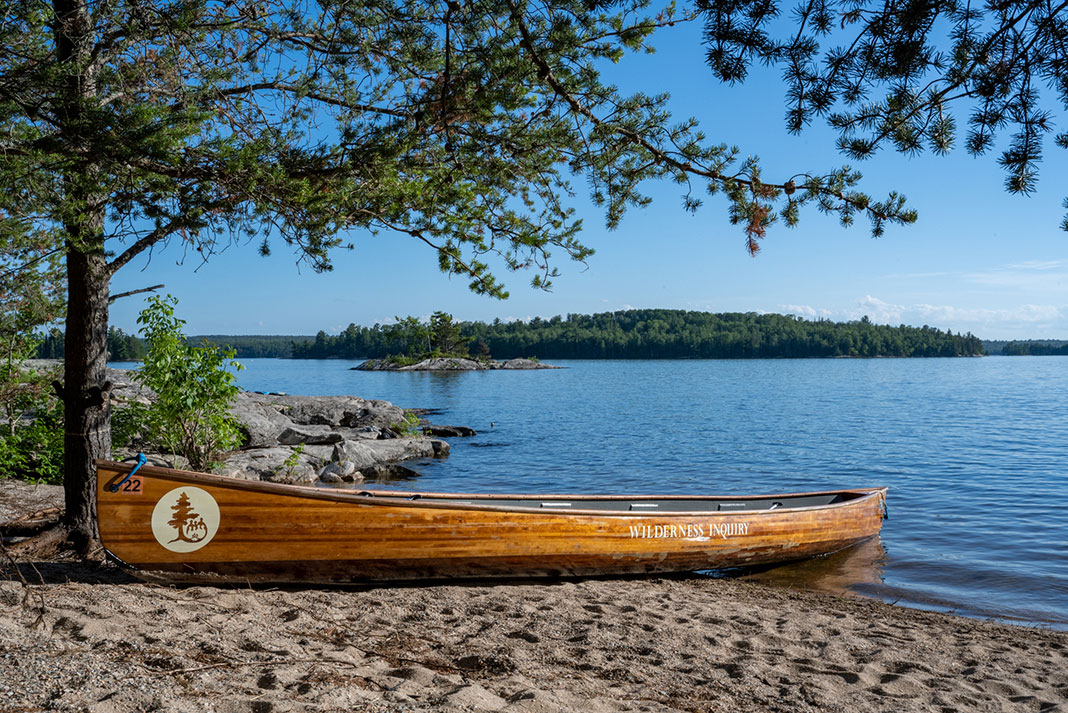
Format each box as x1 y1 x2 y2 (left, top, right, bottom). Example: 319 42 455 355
111 15 1068 339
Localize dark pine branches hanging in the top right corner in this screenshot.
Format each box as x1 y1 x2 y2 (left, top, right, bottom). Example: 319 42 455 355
697 0 1068 229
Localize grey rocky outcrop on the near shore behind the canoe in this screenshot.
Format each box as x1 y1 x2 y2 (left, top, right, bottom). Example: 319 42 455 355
109 370 474 484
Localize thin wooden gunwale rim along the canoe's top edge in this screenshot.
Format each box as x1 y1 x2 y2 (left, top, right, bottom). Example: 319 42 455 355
95 459 886 519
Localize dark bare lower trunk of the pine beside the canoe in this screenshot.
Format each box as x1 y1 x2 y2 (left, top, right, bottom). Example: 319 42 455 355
63 246 111 553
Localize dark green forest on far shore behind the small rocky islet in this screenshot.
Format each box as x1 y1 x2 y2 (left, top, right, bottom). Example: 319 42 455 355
292 310 985 359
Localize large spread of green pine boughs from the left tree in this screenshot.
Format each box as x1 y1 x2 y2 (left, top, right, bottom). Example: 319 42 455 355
0 0 912 305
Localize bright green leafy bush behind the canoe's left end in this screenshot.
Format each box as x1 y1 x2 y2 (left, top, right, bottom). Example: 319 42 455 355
130 296 241 470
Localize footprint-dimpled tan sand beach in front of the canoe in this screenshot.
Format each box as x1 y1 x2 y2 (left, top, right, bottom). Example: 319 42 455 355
0 478 1068 713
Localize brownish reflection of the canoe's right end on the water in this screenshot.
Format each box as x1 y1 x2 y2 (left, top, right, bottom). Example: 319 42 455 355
739 536 886 596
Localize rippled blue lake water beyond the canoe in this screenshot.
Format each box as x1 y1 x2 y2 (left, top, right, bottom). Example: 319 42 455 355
192 357 1068 628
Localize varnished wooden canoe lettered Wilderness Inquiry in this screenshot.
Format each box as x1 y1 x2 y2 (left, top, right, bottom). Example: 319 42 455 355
96 461 886 583
